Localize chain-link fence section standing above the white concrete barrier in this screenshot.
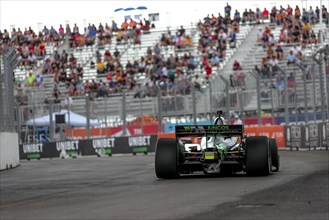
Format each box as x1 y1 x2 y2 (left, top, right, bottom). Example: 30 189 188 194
0 47 17 132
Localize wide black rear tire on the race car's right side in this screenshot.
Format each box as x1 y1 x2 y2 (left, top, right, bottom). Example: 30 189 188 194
246 136 271 176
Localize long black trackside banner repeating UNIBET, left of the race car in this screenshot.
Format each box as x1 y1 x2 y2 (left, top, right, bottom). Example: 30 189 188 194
19 135 157 159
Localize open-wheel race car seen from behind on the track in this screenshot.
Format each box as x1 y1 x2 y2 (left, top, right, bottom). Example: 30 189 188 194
155 111 280 179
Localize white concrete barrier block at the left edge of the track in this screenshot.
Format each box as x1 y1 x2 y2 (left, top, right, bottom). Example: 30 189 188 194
0 132 19 170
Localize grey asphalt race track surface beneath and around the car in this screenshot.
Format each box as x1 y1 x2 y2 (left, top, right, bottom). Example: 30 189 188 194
0 151 329 220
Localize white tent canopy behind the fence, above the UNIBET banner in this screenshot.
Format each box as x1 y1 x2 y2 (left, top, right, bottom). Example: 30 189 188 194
26 110 100 127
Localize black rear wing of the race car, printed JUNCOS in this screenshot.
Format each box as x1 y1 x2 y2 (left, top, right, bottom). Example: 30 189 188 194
176 125 243 138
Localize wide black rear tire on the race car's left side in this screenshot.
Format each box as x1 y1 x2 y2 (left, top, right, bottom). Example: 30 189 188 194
155 138 179 179
